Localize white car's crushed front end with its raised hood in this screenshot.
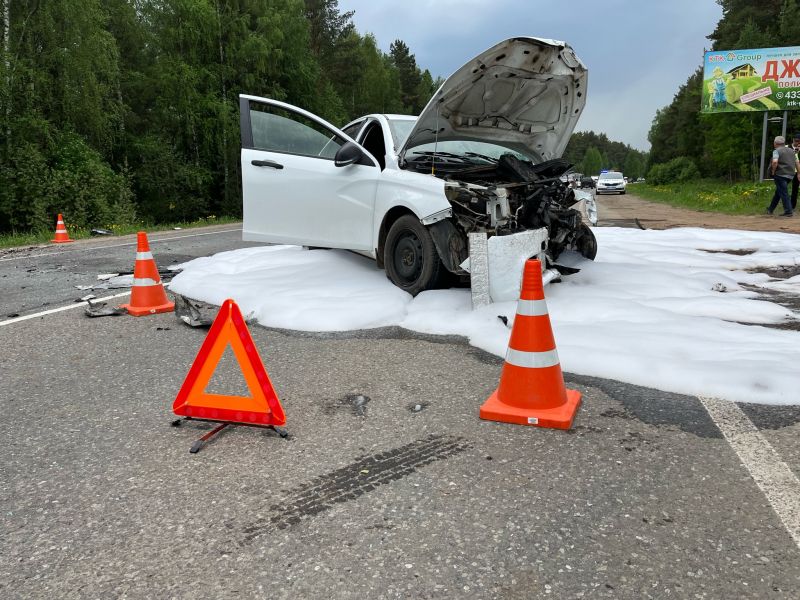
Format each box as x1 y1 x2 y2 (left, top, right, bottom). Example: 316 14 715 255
398 37 597 296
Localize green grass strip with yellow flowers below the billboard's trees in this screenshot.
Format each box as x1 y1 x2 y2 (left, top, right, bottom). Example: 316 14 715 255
628 179 775 215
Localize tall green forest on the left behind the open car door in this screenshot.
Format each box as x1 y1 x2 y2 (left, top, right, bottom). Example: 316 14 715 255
0 0 440 233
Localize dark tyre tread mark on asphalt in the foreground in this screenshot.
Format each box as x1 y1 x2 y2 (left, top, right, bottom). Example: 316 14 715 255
243 435 471 544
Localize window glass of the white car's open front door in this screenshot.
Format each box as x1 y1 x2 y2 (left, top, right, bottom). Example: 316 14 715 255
250 102 345 160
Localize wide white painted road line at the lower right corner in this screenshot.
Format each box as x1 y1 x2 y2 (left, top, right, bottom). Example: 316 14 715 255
700 397 800 547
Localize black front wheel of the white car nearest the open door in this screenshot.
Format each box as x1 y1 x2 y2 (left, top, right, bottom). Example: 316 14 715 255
383 215 446 296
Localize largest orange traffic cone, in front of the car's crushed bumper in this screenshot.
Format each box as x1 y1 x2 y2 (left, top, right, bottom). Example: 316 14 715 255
480 260 581 429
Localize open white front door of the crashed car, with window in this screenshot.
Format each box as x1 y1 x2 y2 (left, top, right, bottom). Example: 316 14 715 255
239 95 381 251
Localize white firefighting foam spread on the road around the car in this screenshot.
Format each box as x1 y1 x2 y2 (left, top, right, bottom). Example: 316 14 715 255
170 228 800 404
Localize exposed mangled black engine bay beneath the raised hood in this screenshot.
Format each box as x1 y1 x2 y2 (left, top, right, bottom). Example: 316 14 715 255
404 151 597 272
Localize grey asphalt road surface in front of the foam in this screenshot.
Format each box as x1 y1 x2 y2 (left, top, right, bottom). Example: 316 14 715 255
0 227 800 599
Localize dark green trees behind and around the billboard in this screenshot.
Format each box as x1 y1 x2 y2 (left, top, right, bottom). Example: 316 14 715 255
647 0 800 183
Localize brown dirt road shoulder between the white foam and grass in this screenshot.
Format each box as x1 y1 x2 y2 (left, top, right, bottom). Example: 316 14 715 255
596 193 800 233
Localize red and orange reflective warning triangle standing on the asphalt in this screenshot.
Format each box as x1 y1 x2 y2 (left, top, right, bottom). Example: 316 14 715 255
172 300 286 425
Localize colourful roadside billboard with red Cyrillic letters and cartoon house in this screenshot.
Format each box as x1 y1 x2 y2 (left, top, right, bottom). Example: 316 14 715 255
700 46 800 113
